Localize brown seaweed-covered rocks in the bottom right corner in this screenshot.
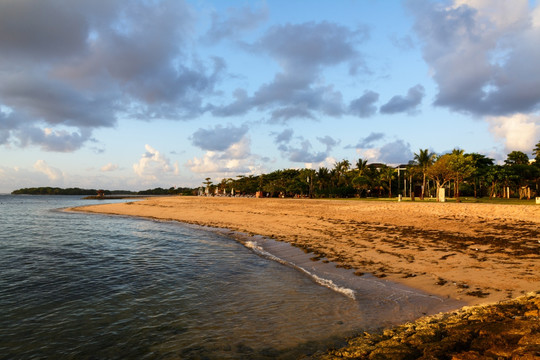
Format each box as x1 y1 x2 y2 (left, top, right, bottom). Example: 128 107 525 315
320 291 540 360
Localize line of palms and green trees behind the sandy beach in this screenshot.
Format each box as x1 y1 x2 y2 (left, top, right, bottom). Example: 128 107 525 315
199 142 540 200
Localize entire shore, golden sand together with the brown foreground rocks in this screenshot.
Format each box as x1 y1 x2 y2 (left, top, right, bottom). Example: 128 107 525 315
66 197 540 359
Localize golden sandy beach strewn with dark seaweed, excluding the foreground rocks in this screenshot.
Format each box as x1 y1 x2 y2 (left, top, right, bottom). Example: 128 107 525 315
69 197 540 305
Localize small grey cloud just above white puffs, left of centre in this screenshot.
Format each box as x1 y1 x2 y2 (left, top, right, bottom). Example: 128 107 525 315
190 124 249 151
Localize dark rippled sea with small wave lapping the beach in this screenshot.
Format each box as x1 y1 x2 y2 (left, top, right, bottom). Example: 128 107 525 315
0 195 459 359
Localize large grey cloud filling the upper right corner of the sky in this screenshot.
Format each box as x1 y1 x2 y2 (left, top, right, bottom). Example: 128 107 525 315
407 0 540 116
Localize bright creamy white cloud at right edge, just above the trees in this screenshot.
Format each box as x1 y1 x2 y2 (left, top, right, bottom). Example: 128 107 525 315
487 114 540 154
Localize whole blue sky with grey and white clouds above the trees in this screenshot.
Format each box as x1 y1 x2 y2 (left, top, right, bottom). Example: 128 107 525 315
0 0 540 193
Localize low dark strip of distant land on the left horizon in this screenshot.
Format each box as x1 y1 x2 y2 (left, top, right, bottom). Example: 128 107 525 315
11 186 197 198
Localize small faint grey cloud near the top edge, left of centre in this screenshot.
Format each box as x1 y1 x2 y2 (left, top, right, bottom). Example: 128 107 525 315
203 5 269 43
